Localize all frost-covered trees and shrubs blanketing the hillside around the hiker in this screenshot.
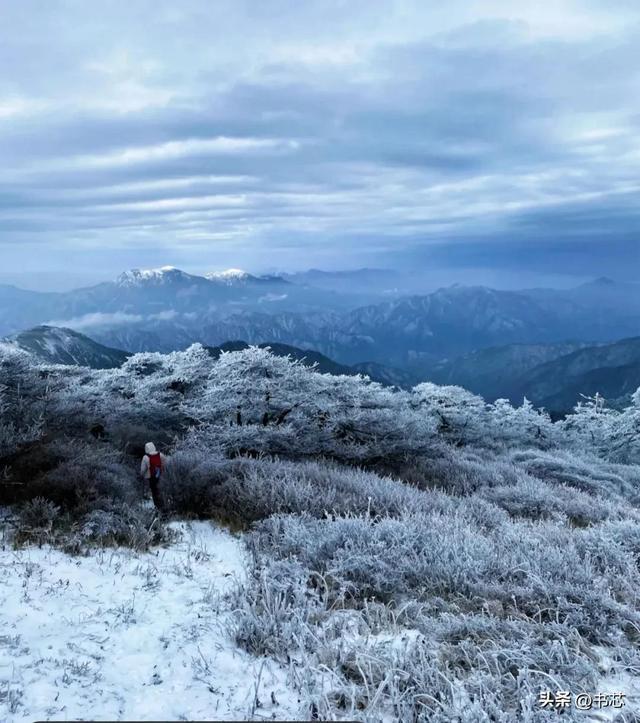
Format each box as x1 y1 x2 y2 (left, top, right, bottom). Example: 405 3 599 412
0 345 640 723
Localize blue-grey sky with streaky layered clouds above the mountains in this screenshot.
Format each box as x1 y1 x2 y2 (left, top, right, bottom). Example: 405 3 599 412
0 0 640 287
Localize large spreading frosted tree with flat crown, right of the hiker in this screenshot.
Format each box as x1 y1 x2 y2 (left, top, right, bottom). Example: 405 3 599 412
185 347 435 459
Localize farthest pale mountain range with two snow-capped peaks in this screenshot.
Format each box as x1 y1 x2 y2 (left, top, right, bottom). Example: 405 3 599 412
0 266 360 342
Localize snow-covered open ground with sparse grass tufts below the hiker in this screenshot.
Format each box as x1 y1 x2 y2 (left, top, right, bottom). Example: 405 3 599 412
0 522 301 721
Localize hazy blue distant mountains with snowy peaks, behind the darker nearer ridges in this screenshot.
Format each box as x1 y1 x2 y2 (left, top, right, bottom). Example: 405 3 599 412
0 267 640 362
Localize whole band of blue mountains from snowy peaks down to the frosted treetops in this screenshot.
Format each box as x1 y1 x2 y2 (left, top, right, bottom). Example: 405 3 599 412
0 267 640 409
